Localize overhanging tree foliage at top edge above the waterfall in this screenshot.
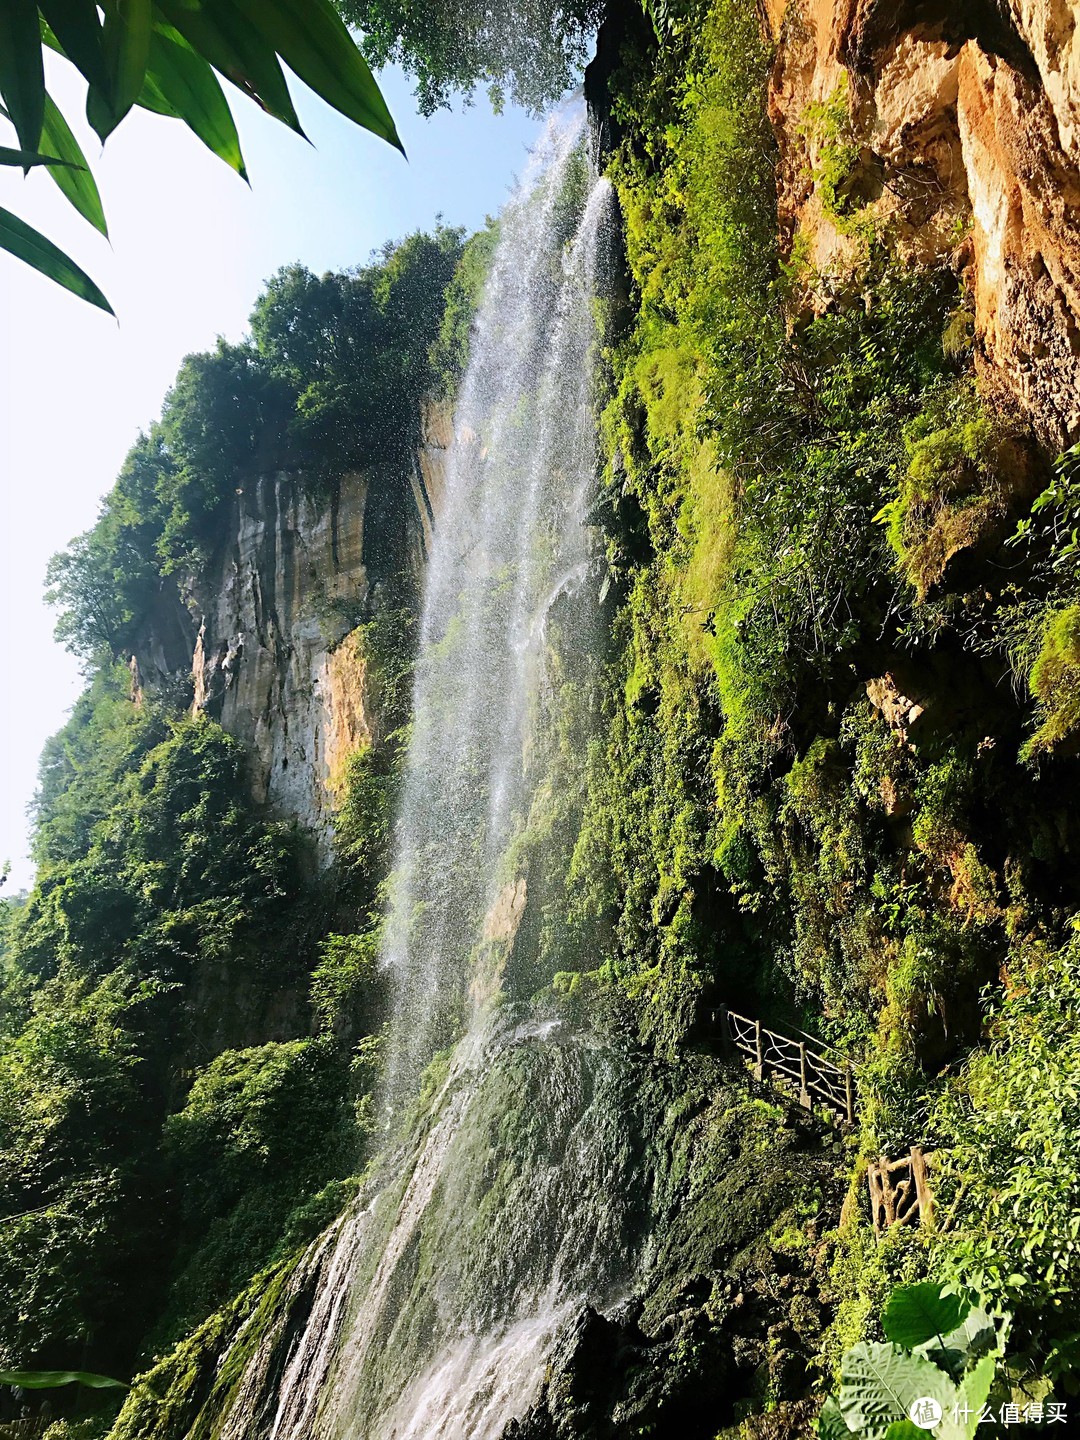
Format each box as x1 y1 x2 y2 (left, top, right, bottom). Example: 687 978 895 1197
336 0 603 115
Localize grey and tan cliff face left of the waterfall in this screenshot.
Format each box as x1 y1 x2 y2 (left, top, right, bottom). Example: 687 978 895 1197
132 406 451 845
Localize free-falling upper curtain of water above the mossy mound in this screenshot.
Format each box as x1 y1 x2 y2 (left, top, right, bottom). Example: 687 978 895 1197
384 107 612 1093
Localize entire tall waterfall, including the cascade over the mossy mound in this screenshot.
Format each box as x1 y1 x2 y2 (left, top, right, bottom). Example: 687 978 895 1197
214 104 636 1440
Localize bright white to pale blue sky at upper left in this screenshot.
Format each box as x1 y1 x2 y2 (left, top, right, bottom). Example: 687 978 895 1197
0 56 539 894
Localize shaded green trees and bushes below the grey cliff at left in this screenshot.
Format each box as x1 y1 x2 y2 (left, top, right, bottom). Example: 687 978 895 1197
0 648 408 1411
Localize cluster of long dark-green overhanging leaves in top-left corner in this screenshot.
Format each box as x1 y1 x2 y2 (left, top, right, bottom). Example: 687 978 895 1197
0 0 402 314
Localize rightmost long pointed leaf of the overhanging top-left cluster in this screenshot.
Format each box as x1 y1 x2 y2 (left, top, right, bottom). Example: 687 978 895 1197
228 0 405 154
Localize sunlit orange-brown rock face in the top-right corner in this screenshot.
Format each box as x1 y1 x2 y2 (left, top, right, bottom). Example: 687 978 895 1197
766 0 1080 446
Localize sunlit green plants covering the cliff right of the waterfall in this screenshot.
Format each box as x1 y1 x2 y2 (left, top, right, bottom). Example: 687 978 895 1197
535 0 1080 1416
